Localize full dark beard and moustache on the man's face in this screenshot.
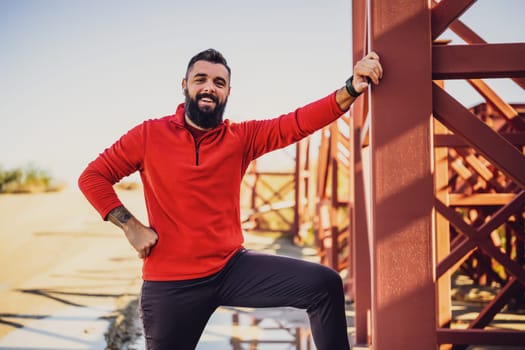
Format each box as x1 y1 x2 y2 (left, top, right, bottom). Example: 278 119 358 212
184 90 228 129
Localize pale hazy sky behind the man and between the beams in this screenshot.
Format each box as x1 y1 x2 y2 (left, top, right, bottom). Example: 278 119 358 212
0 0 525 189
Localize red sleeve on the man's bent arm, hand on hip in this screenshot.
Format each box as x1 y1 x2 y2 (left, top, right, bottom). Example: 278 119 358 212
78 123 145 220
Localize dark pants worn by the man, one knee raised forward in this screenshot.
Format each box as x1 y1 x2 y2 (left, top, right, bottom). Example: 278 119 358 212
141 249 350 350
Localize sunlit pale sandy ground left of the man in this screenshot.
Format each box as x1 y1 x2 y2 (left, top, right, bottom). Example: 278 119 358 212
0 190 145 349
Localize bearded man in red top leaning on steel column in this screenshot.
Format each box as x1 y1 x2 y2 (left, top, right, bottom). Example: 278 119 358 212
79 49 382 350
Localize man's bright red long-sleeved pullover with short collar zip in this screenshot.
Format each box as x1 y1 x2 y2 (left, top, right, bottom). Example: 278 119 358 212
78 93 344 281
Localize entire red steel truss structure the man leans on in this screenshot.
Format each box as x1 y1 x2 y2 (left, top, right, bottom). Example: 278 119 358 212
239 0 525 350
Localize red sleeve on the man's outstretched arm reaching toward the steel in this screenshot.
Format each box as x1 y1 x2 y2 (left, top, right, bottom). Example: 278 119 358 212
237 92 344 164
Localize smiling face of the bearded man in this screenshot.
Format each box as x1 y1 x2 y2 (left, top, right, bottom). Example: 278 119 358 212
182 61 230 129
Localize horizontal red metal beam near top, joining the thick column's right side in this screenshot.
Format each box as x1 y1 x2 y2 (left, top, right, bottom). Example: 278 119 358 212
432 43 525 80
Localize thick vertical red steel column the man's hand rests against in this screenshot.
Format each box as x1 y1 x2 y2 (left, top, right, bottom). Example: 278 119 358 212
369 0 437 350
